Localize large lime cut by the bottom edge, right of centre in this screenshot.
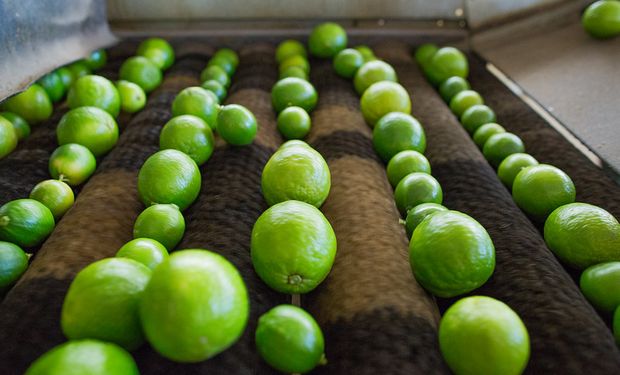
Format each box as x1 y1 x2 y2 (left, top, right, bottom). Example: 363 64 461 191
439 296 530 375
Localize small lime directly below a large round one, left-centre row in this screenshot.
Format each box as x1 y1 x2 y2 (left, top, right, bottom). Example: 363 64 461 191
133 204 185 251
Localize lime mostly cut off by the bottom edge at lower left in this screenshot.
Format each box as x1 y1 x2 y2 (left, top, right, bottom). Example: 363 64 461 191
26 340 140 375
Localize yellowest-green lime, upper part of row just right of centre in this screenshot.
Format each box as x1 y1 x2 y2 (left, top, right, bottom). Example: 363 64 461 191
360 81 411 127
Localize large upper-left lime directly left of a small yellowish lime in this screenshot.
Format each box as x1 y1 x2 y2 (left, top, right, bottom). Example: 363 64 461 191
67 75 121 117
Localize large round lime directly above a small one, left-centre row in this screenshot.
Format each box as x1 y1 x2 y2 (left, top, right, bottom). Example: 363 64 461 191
138 150 202 210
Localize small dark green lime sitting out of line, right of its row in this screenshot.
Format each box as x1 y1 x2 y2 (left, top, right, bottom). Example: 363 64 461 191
216 104 258 146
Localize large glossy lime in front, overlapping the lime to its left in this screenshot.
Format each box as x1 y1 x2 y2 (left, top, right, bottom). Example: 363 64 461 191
140 250 249 362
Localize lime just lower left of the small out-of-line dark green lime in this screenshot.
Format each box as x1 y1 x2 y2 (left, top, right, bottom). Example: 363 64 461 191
159 115 215 166
